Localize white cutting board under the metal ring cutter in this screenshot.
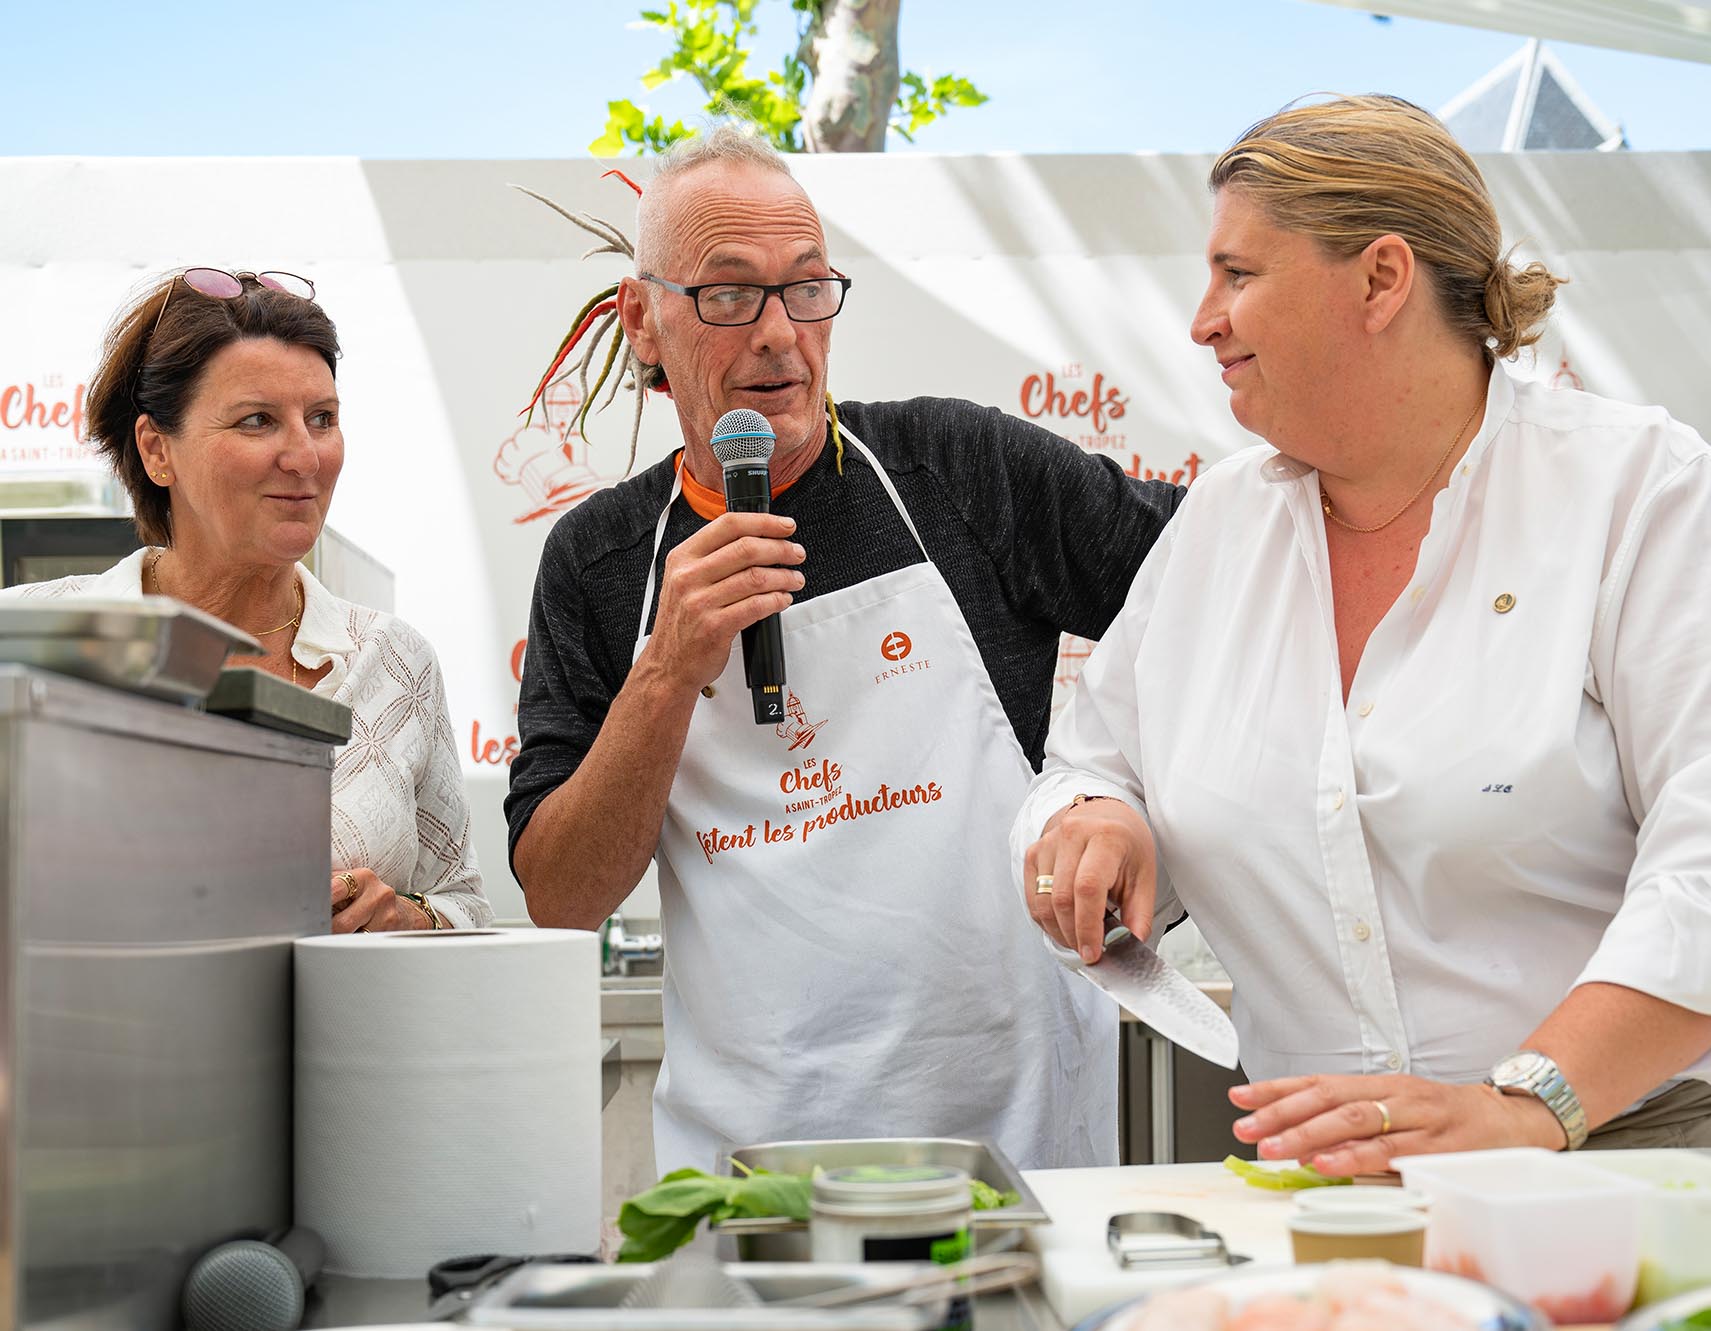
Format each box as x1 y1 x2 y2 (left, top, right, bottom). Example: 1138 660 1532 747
1021 1165 1295 1326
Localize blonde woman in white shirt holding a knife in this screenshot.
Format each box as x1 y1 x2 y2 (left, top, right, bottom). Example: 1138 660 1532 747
1013 98 1711 1174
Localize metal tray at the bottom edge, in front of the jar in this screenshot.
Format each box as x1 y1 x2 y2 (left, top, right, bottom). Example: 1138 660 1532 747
464 1257 948 1331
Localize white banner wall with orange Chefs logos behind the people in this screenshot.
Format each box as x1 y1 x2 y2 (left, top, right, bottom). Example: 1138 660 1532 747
0 152 1711 919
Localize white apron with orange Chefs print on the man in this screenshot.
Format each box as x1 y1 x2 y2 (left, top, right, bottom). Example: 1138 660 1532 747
636 431 1117 1174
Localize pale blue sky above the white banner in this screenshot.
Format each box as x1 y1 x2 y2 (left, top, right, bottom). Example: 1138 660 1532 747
0 0 1711 157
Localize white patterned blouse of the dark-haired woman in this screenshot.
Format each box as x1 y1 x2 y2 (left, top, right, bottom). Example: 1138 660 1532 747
7 549 493 929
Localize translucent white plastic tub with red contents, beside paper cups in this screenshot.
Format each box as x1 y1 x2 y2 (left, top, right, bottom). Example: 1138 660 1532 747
1396 1148 1646 1322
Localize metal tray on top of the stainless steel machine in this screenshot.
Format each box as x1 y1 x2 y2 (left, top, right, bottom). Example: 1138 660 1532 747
0 595 262 703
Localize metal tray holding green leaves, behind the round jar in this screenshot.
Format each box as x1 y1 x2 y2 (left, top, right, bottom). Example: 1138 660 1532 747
712 1138 1052 1263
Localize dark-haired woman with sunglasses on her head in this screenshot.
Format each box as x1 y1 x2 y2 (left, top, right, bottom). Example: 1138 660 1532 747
6 269 493 932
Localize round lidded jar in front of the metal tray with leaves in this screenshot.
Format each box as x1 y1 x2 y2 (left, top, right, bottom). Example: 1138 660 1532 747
808 1165 974 1331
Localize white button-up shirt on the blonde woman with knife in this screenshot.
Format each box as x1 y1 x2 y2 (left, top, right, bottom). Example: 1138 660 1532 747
1013 368 1711 1081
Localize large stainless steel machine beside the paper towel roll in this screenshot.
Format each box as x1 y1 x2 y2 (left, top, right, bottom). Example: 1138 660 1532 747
0 666 332 1331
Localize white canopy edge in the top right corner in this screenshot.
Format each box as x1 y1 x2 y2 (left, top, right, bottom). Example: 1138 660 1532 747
1319 0 1711 63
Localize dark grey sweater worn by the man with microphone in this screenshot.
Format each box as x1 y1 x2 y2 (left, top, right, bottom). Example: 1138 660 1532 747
505 397 1182 854
